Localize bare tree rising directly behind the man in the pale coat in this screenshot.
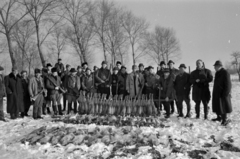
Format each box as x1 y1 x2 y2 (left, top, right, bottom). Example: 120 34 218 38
122 12 148 65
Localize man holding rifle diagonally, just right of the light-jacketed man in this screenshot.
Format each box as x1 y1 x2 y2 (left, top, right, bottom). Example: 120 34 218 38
46 67 64 115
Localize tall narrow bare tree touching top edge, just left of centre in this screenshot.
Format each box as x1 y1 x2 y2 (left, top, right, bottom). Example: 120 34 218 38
91 0 115 61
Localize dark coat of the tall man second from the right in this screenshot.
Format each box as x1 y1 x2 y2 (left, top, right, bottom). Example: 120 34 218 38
190 68 213 102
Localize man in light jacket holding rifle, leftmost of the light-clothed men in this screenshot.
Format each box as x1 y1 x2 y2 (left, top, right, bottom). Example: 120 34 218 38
28 68 47 119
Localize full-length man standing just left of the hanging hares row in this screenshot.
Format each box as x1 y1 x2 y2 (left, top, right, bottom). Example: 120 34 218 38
66 68 81 114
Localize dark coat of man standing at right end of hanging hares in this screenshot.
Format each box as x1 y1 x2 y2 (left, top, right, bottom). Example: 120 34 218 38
160 75 175 99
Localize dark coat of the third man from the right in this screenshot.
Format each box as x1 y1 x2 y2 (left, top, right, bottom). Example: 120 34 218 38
174 72 191 98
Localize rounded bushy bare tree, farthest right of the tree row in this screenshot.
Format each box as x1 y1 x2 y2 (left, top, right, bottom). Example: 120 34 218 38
142 26 180 64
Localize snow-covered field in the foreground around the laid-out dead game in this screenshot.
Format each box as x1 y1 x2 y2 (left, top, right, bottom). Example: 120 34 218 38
0 82 240 159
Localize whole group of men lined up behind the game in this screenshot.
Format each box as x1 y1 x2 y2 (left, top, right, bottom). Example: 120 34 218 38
0 59 232 125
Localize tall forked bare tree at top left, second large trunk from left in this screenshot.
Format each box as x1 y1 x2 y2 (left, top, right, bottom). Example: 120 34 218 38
23 0 62 66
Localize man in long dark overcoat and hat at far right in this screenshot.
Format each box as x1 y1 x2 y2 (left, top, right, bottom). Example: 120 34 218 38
212 61 232 125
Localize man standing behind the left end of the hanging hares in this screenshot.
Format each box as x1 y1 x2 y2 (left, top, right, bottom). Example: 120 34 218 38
82 68 95 94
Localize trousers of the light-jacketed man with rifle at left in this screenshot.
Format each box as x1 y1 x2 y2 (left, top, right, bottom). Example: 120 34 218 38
33 94 44 118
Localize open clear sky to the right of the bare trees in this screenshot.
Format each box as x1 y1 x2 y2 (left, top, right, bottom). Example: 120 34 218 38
115 0 240 70
